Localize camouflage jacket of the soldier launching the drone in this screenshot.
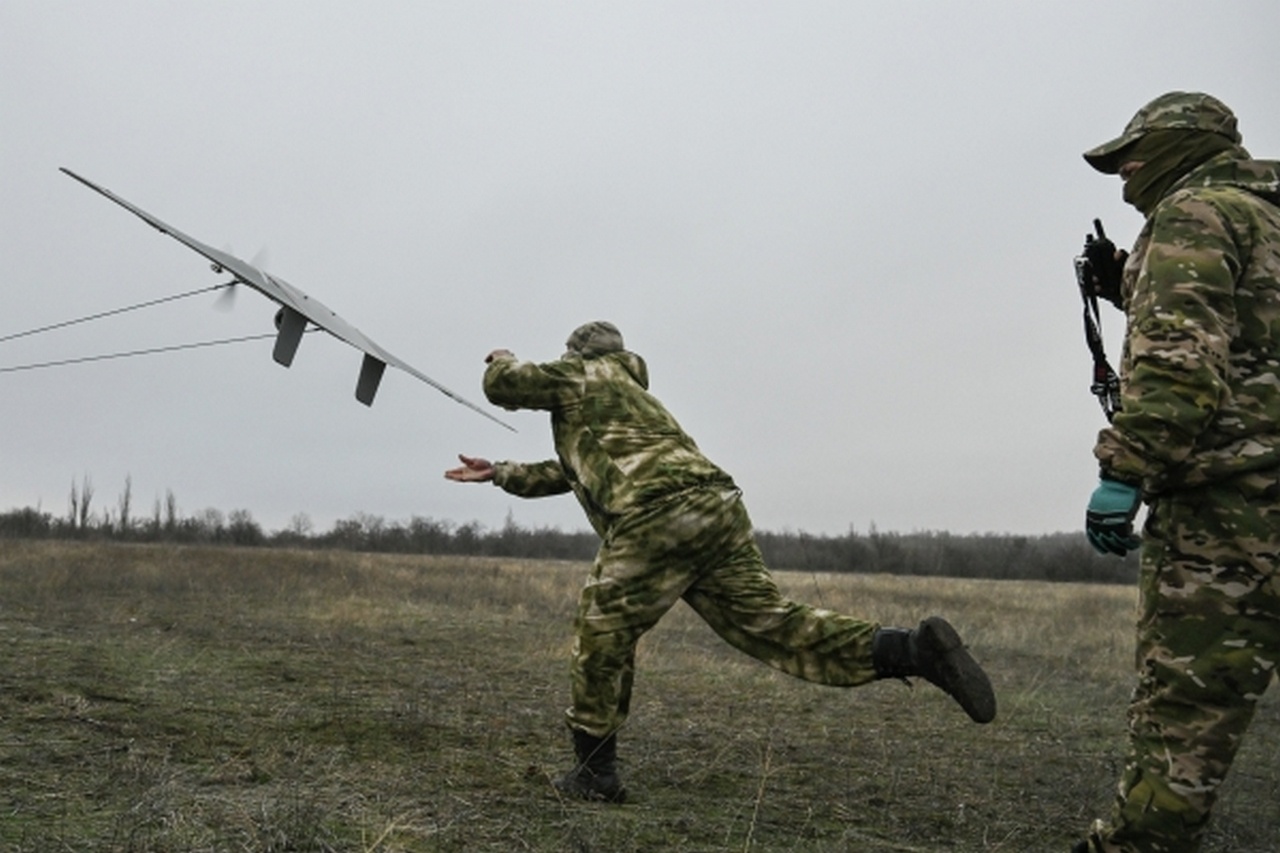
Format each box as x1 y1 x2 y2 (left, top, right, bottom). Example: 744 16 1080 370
484 351 735 537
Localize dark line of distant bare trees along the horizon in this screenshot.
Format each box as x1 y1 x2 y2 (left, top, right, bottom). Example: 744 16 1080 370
0 475 1137 583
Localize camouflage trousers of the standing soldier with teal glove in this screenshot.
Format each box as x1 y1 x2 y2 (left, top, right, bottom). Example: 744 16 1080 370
1089 474 1280 853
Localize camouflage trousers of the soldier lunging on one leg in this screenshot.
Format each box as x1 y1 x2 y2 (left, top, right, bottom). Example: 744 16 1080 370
567 489 878 738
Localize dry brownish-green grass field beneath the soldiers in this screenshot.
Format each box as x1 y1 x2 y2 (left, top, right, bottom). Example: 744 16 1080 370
0 540 1280 853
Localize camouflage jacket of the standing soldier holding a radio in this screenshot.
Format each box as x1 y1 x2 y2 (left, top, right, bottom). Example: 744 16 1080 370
1094 152 1280 494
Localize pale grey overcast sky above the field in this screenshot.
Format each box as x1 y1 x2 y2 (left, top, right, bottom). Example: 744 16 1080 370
0 0 1280 534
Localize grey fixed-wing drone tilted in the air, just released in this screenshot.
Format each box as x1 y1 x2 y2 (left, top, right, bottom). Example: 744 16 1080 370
61 168 515 432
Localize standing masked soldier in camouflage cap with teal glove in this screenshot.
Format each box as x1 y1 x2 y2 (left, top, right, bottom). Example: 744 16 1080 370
1074 92 1280 853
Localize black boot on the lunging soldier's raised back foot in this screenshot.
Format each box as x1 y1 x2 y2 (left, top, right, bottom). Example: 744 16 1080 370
872 616 996 722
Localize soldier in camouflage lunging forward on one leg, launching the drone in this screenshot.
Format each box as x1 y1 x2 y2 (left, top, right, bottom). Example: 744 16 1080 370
445 321 996 802
